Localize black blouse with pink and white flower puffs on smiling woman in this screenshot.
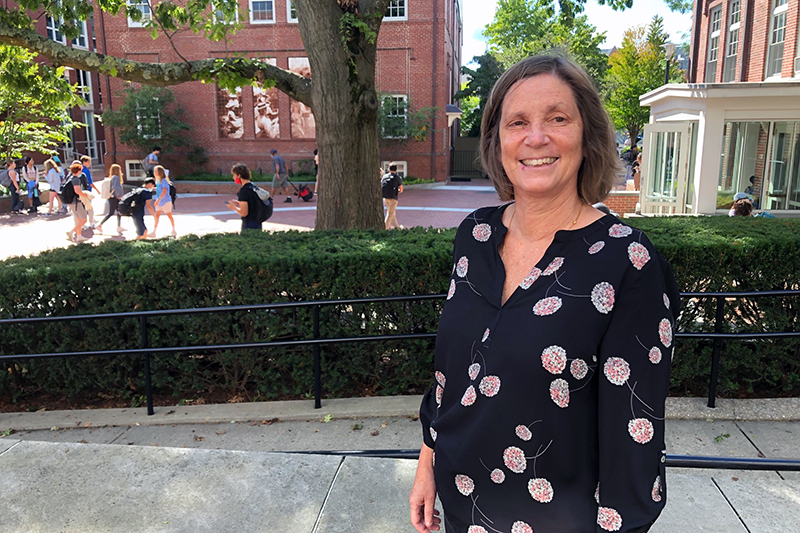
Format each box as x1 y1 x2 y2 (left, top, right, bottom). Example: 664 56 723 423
420 206 680 533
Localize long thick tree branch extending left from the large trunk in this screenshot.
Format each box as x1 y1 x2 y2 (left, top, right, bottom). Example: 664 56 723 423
0 20 314 109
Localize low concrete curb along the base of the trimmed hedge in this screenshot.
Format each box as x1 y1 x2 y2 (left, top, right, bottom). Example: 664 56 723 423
0 395 800 433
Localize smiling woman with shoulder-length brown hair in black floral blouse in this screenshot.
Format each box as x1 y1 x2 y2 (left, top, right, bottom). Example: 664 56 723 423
409 56 679 533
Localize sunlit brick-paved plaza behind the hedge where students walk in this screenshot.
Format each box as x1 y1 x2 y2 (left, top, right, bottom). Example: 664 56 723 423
0 180 500 260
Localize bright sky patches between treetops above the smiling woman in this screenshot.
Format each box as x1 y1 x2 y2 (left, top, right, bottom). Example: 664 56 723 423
461 0 692 64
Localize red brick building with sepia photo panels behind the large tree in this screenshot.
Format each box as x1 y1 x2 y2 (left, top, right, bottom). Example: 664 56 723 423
95 0 462 180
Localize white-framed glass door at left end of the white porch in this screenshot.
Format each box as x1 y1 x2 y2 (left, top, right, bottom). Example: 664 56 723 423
640 122 691 215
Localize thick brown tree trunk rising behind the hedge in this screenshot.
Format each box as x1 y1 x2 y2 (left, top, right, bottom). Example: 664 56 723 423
295 0 388 229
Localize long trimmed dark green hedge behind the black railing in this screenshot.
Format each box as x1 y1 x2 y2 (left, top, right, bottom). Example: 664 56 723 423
0 217 800 400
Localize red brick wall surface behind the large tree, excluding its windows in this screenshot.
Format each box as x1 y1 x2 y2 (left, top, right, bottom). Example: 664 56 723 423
99 0 461 181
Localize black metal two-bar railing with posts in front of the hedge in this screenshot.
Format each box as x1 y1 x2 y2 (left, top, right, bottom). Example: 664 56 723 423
0 290 800 415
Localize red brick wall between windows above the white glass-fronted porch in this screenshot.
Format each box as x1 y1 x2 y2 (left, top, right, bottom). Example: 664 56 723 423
692 0 800 83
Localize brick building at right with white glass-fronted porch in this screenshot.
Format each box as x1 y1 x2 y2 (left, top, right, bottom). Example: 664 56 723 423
640 0 800 215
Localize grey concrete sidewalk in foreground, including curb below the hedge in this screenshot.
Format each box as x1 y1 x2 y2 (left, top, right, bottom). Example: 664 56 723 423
0 396 800 533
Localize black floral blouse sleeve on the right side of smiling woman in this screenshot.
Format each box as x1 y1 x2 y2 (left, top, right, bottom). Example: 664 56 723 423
596 239 680 533
